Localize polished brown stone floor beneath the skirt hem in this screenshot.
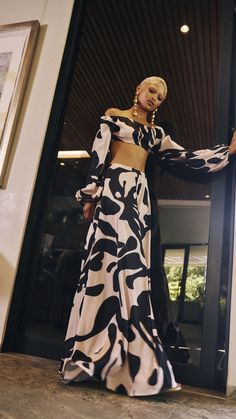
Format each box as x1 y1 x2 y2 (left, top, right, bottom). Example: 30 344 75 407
0 353 236 419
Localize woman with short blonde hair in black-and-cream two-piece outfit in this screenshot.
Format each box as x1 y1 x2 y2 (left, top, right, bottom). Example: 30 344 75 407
59 77 236 396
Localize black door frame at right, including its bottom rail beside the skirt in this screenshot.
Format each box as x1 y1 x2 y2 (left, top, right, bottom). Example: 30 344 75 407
173 0 236 391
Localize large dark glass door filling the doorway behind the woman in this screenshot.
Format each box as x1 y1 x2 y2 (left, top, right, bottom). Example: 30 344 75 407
4 0 234 394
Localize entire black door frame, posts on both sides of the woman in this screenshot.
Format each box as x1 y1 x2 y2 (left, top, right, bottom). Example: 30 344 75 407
3 0 234 394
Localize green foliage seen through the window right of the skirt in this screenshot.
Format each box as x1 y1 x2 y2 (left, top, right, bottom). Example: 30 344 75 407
165 265 205 306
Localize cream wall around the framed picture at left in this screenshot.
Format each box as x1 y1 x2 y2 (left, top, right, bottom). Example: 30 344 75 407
0 0 74 347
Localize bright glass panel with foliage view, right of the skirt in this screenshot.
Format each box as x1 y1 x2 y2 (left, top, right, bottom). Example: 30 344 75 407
164 245 208 366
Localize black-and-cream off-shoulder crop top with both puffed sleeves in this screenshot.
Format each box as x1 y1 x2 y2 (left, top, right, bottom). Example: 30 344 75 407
76 115 229 202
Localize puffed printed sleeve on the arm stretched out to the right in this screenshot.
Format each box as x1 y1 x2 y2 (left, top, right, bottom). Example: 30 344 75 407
157 135 229 173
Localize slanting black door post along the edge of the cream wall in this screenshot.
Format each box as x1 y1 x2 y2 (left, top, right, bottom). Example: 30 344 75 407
2 0 86 352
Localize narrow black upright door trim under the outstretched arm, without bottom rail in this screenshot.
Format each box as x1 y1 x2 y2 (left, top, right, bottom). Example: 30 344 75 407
200 0 234 388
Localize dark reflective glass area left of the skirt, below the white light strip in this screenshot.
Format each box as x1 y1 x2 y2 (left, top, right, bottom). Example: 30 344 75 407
25 159 88 342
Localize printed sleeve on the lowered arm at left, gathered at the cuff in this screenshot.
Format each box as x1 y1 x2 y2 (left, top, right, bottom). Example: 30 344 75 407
75 116 114 203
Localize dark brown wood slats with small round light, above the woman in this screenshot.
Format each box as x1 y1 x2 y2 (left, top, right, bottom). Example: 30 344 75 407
60 0 221 199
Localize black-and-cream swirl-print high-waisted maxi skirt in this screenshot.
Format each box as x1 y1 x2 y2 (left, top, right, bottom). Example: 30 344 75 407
62 164 177 396
